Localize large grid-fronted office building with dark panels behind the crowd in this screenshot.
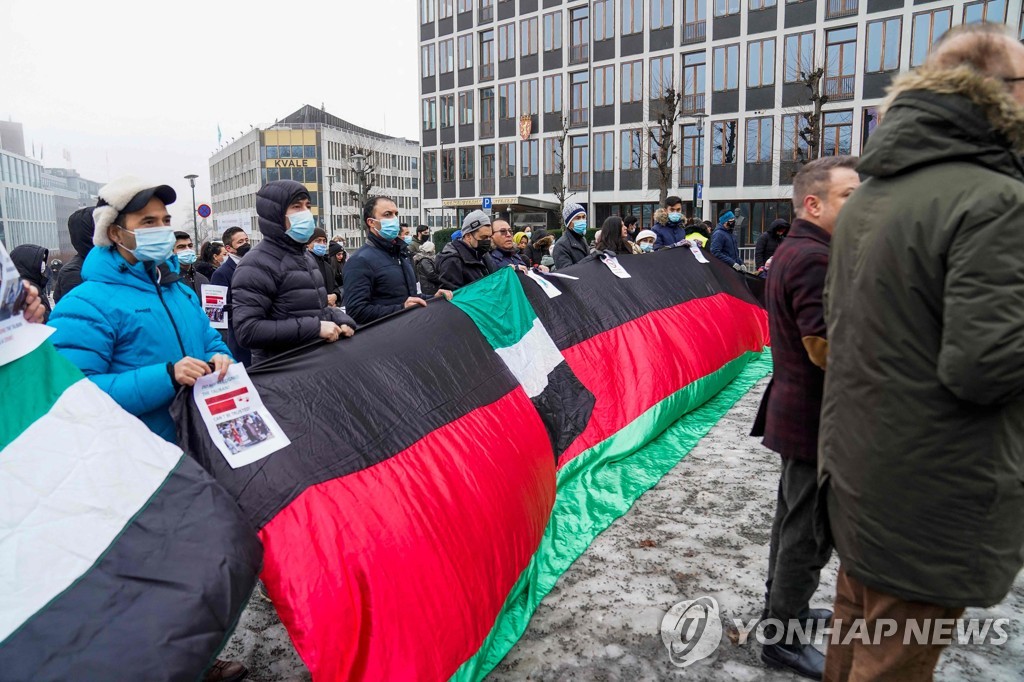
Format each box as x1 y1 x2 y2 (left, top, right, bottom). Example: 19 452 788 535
419 0 1021 244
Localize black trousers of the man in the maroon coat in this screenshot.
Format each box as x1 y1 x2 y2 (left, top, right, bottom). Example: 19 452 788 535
765 459 833 623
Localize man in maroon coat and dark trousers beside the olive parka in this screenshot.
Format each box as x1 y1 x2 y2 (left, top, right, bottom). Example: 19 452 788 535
752 157 860 679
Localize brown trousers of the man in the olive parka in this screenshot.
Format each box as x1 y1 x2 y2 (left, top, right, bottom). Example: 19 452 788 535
824 566 964 682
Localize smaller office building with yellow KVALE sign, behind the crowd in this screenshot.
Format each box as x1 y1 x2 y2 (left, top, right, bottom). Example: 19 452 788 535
209 104 420 249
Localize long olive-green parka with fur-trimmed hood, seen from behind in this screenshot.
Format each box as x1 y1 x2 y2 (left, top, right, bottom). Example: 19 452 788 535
819 68 1024 608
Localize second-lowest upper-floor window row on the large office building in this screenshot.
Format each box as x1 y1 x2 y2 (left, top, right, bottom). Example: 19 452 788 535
421 8 951 135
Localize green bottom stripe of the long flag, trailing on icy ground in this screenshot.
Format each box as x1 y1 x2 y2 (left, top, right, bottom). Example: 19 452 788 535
452 349 771 682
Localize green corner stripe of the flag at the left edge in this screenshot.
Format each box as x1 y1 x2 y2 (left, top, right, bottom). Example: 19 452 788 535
0 342 82 450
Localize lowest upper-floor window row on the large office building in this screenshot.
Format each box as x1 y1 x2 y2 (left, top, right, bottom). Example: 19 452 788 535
423 108 878 188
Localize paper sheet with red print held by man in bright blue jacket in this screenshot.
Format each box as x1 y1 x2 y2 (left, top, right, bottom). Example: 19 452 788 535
193 363 292 469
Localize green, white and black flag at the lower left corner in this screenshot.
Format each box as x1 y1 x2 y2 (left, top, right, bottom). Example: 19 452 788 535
0 342 260 681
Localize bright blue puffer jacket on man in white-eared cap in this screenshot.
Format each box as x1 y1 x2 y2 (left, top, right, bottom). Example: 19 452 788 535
49 247 229 442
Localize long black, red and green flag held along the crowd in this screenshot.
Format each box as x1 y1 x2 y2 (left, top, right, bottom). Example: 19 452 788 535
174 244 768 680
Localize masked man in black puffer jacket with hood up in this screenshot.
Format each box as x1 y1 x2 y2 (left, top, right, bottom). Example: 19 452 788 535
231 180 355 364
